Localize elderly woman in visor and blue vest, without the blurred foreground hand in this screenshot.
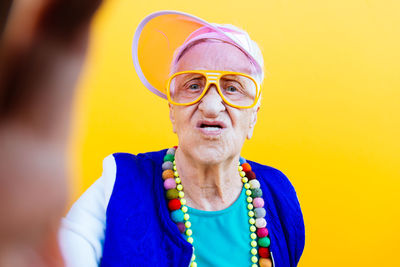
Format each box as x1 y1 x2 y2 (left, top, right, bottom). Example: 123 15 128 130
60 11 304 267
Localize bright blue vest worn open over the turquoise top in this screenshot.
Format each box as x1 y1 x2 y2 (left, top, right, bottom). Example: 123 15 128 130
101 150 305 267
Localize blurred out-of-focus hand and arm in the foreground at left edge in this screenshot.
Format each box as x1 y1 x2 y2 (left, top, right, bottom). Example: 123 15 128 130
0 0 101 267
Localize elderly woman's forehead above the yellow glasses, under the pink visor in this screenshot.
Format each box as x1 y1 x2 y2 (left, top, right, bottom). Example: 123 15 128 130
173 41 255 74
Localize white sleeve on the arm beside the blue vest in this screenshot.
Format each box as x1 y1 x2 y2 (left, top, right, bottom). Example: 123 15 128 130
59 155 117 267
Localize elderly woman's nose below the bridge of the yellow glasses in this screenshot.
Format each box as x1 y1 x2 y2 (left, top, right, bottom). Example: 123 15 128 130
199 84 225 117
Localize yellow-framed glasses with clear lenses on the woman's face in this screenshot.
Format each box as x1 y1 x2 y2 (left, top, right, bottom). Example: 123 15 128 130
168 72 259 108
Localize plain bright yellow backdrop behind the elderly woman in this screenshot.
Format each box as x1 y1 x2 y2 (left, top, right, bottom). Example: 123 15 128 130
70 0 400 267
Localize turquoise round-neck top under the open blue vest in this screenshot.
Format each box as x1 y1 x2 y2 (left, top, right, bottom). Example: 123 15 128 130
183 189 252 267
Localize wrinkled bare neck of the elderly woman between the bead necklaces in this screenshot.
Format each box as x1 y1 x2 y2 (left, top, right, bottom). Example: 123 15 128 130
175 149 242 211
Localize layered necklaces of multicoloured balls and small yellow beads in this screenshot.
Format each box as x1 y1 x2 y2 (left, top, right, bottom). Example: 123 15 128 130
162 147 272 267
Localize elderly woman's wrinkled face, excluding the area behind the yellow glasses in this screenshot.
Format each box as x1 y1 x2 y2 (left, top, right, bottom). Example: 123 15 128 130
170 42 258 164
